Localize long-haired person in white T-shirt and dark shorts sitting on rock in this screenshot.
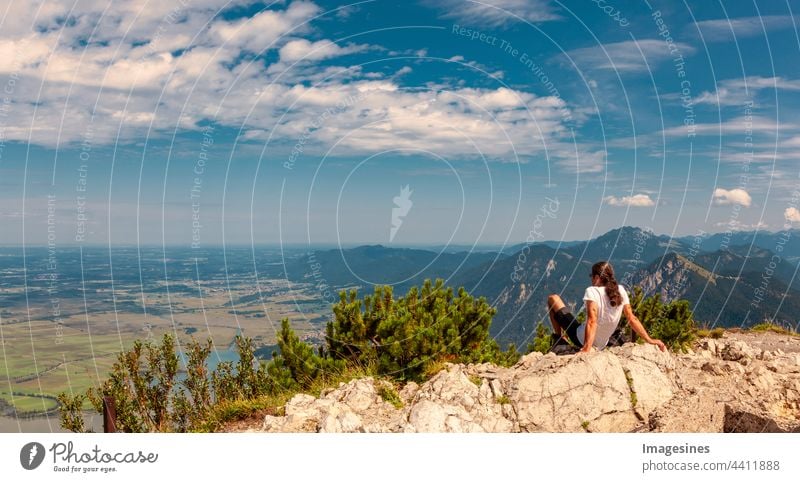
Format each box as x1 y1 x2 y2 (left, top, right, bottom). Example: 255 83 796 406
547 261 667 352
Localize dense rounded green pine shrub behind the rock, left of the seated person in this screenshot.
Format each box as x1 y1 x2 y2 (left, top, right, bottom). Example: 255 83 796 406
322 280 519 380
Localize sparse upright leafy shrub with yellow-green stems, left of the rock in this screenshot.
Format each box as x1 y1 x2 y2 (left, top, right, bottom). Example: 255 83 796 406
58 334 290 432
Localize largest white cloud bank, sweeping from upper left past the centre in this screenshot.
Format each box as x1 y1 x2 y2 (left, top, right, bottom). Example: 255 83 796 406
0 0 606 172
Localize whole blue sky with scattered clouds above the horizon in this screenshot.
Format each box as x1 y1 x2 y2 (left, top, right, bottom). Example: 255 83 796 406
0 0 800 246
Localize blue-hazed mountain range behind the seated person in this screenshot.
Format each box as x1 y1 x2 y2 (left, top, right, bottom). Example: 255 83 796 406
282 226 800 346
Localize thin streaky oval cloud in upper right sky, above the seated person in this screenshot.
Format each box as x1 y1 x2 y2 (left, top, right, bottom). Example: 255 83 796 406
566 39 695 72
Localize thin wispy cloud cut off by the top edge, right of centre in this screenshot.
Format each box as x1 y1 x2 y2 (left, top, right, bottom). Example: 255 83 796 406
426 0 561 27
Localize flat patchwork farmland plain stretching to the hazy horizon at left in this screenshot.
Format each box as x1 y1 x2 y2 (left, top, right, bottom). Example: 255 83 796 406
0 248 331 424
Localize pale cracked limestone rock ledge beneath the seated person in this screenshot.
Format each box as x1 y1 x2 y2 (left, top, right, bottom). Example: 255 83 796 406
244 333 800 432
